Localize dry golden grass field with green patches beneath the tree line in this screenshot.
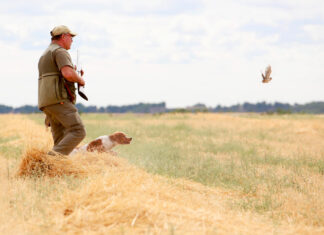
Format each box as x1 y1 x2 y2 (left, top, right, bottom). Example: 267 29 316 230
0 113 324 234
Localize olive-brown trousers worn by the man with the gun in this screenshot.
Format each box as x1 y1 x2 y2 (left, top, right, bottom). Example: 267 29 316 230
42 101 86 155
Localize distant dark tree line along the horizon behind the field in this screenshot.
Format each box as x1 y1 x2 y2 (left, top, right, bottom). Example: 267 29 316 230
0 102 324 114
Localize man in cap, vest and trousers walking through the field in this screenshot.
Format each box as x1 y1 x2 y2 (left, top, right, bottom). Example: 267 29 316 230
38 25 86 155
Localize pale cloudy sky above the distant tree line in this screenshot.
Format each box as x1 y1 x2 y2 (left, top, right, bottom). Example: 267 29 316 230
0 0 324 108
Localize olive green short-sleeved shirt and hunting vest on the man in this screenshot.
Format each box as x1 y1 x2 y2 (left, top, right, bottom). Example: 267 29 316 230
38 43 76 109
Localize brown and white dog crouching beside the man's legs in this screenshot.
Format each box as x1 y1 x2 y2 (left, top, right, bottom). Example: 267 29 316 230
70 132 132 155
